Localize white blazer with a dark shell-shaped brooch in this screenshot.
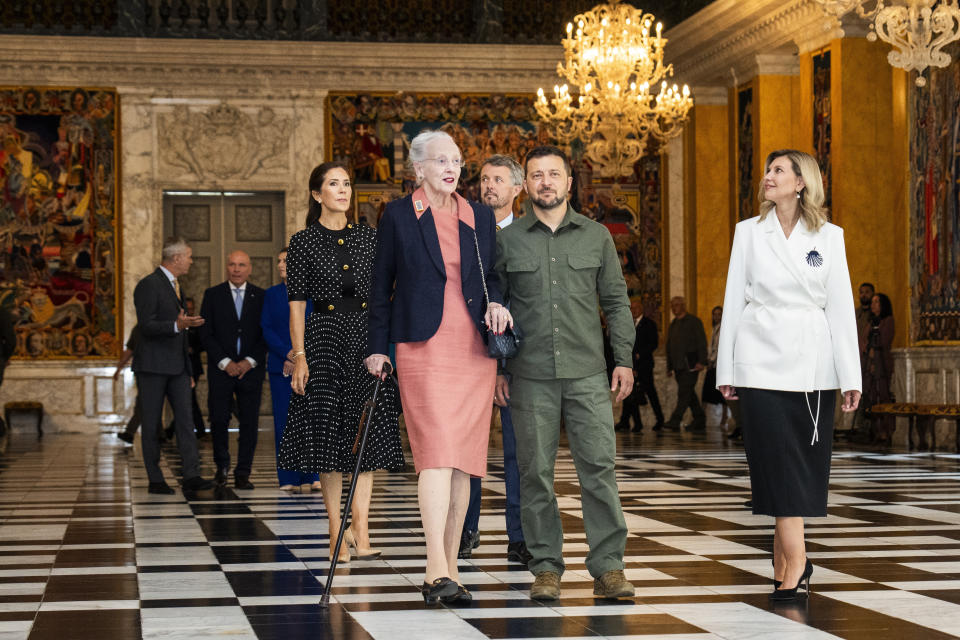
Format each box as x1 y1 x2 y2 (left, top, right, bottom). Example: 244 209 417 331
717 210 862 391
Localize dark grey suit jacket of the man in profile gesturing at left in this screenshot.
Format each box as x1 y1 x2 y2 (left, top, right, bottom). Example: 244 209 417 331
133 267 193 376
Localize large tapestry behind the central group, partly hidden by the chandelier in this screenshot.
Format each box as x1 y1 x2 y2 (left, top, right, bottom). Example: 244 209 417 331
326 93 663 317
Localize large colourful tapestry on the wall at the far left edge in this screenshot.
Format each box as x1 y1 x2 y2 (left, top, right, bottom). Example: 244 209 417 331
0 87 121 359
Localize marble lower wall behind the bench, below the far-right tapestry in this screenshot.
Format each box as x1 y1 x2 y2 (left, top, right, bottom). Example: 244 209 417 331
893 346 960 451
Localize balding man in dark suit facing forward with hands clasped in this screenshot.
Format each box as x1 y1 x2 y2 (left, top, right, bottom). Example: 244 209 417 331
200 251 267 489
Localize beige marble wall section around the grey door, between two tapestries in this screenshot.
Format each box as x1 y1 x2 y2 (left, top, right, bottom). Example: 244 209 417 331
120 89 326 340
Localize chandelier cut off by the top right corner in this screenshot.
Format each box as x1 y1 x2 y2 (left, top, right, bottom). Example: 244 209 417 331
817 0 960 87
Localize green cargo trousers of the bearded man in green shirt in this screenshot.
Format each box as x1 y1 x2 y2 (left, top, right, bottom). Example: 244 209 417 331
510 371 627 578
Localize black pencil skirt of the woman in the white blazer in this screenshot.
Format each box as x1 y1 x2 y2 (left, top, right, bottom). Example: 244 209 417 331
737 387 836 518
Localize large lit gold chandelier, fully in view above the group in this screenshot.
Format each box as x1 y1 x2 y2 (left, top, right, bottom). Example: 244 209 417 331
535 0 693 177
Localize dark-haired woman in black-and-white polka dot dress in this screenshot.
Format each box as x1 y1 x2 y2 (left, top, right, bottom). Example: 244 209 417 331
279 162 404 561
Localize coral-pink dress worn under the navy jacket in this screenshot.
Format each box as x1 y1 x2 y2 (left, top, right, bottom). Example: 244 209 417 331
397 191 497 477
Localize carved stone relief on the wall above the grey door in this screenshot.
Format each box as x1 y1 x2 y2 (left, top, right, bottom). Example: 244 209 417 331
157 103 293 180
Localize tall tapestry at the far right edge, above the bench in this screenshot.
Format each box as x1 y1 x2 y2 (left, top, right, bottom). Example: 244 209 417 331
912 57 960 342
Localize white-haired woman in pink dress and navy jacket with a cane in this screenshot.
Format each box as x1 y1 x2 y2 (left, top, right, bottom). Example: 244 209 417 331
366 131 513 604
